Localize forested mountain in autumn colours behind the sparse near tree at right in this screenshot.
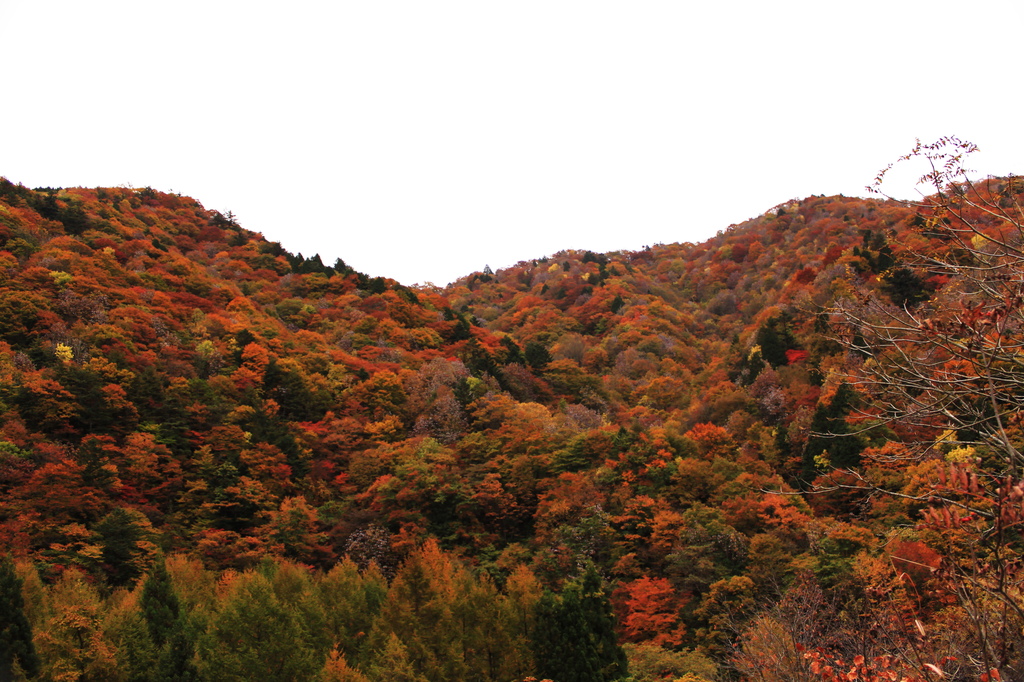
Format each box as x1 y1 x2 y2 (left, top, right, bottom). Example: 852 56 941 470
0 174 995 680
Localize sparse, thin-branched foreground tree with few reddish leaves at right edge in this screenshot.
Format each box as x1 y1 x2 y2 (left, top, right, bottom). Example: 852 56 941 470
831 137 1024 679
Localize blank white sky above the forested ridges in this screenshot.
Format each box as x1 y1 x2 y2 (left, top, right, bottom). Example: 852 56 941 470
0 0 1024 285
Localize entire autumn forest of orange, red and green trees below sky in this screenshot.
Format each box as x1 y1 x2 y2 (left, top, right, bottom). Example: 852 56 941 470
0 138 1024 682
